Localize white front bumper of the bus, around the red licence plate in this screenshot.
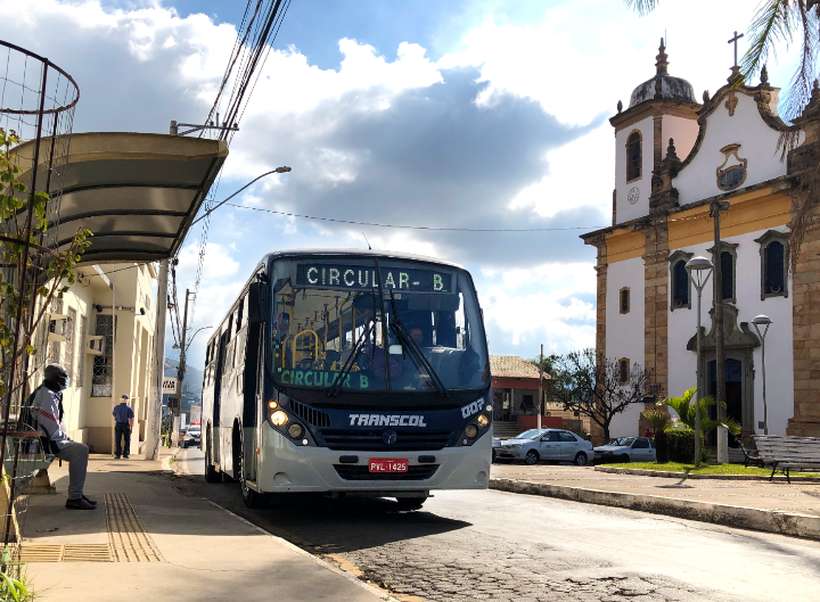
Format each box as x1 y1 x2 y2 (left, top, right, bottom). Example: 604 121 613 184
256 433 492 495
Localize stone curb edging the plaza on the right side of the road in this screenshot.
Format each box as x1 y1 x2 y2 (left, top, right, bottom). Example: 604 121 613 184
490 479 820 541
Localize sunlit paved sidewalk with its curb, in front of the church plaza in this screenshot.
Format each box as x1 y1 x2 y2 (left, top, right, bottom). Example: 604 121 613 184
490 464 820 540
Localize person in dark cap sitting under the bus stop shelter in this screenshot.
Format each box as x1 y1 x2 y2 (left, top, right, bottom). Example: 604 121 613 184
31 364 97 510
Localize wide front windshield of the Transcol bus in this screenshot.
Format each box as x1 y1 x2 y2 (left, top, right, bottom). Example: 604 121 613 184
272 256 489 396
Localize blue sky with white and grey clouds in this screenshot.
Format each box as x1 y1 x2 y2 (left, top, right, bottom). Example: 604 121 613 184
0 0 808 363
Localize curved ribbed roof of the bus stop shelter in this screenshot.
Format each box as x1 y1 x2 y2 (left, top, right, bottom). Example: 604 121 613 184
12 132 228 263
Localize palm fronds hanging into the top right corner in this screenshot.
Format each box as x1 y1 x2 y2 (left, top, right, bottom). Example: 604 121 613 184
625 0 820 119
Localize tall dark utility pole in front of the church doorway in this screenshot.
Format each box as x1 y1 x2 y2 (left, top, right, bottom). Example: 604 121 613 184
707 200 729 464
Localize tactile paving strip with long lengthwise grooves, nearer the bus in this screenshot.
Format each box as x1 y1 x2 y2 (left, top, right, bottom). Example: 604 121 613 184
105 493 162 562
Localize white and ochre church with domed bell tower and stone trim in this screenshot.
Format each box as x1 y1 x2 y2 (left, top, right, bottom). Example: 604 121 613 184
582 40 820 436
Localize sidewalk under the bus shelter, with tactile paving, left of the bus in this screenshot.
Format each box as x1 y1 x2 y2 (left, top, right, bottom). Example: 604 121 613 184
21 451 385 602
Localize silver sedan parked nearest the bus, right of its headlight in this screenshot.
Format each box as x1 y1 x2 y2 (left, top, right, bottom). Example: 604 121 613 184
493 429 594 466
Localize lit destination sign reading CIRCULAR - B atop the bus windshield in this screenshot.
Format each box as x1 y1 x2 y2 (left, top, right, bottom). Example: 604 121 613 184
296 263 453 293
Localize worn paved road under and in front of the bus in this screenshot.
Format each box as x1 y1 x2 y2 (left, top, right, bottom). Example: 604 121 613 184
174 450 820 602
